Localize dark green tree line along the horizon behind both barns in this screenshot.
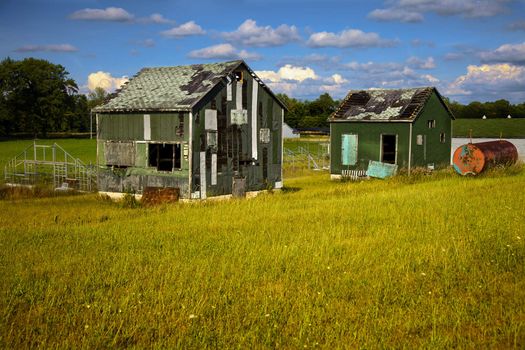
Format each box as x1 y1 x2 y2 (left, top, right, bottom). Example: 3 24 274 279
0 58 525 136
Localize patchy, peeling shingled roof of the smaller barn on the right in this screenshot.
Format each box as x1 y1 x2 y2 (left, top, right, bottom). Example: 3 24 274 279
329 87 454 122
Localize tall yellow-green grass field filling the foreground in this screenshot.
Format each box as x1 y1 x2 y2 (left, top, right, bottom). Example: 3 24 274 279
0 167 525 349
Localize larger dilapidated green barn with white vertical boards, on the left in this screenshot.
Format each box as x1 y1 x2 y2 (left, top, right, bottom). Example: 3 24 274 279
93 60 285 199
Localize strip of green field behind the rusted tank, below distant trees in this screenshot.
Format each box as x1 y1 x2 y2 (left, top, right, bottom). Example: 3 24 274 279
452 119 525 138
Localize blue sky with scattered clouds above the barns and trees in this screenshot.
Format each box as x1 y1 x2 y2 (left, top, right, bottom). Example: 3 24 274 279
0 0 525 103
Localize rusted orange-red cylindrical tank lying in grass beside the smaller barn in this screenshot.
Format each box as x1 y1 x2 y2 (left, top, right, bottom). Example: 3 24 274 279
452 140 518 175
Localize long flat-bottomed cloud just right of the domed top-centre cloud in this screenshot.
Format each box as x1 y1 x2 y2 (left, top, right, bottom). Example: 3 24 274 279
307 29 397 48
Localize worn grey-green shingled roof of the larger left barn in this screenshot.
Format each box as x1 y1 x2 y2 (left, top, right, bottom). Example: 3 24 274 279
93 60 282 112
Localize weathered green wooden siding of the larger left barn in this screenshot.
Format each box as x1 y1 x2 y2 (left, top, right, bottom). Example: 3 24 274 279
97 70 282 197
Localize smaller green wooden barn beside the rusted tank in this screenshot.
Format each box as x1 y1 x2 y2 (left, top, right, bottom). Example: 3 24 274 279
329 87 454 179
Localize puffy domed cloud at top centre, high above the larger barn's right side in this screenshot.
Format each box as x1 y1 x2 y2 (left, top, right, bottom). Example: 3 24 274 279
222 19 301 47
